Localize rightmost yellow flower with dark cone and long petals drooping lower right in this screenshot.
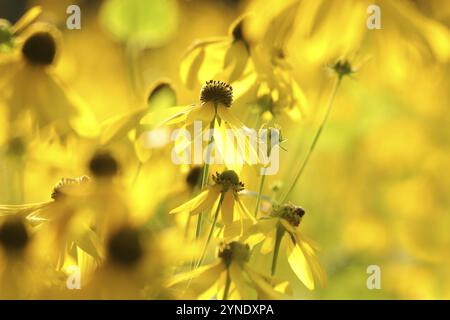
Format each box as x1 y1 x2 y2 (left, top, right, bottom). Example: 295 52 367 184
245 204 326 290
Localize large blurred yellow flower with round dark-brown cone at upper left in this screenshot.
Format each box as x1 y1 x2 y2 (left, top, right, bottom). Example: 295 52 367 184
0 23 98 138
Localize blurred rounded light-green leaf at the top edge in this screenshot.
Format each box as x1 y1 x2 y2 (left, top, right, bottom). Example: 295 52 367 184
100 0 178 47
